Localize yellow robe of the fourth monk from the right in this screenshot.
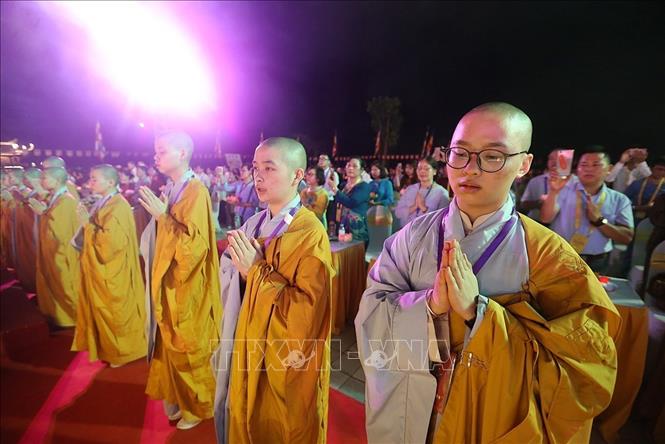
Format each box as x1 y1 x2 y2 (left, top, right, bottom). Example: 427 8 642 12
72 194 147 365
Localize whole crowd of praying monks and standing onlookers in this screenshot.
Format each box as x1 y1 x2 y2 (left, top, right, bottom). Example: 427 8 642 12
1 103 665 442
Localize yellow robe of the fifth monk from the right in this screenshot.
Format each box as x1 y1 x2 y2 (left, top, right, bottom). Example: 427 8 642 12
37 193 81 327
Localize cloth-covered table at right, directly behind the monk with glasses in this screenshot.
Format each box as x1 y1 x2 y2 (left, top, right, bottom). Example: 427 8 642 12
594 278 649 443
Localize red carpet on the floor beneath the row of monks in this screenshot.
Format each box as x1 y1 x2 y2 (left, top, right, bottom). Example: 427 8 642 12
0 272 366 444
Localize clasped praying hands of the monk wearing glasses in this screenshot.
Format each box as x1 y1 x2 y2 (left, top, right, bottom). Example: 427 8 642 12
427 240 479 321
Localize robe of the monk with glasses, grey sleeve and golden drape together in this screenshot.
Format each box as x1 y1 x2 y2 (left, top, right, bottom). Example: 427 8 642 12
355 211 620 443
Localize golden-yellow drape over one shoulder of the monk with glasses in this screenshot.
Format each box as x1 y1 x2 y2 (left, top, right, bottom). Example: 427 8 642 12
434 215 621 444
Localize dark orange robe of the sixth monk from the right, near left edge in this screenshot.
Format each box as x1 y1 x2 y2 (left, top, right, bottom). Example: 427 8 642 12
15 197 39 293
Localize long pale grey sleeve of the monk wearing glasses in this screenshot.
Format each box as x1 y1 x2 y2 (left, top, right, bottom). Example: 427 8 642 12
355 225 441 442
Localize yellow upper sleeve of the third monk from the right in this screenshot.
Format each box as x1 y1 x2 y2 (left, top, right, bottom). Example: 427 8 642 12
157 193 210 282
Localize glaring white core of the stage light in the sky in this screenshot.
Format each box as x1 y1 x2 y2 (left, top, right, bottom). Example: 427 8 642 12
53 1 216 113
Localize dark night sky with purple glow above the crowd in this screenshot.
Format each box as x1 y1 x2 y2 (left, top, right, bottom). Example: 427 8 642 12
1 2 665 162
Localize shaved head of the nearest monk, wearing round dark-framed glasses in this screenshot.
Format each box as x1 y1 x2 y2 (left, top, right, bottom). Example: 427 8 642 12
444 102 533 221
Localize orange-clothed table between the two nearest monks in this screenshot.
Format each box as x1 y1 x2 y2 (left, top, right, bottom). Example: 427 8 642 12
330 241 367 335
